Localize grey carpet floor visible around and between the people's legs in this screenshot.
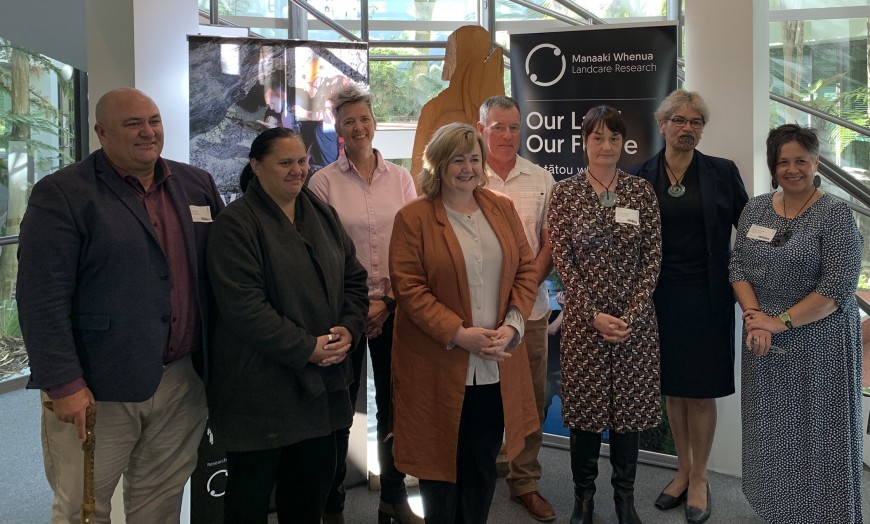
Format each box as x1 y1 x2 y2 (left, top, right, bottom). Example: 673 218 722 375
0 390 870 524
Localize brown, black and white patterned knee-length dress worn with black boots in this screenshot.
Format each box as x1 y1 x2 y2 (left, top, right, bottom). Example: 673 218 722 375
548 171 662 433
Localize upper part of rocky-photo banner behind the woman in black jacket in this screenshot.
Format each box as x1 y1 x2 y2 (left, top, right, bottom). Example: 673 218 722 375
187 36 368 202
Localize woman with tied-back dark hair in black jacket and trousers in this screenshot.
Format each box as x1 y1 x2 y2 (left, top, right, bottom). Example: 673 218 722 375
207 128 368 524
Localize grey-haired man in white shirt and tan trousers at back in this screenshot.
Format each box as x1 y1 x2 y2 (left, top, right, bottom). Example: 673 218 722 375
477 96 556 522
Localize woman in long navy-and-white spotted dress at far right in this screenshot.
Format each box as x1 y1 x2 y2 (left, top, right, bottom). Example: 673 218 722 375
730 124 863 524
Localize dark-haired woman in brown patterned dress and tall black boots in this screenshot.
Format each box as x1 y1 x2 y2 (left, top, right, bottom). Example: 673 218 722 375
549 106 661 524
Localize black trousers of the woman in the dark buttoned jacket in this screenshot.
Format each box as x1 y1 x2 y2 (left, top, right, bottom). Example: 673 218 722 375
224 433 336 524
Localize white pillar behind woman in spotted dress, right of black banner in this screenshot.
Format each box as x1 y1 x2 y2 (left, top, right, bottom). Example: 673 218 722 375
686 0 770 476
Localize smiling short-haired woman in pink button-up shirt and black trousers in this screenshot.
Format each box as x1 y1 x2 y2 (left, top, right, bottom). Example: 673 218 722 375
308 85 423 524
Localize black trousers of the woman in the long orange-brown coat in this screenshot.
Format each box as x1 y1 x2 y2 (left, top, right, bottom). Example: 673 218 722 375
420 384 504 524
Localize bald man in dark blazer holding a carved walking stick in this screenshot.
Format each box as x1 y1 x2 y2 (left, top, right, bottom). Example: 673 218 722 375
17 88 224 523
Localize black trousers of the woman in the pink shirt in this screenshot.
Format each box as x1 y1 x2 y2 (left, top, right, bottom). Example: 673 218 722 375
326 314 408 513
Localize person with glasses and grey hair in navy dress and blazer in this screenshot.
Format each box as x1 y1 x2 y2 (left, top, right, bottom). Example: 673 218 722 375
628 89 748 523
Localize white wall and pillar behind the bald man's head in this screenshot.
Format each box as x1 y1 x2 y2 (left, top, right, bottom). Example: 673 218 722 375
0 0 199 162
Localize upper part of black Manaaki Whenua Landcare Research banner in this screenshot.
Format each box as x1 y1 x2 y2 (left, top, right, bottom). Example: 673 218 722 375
511 22 678 180
